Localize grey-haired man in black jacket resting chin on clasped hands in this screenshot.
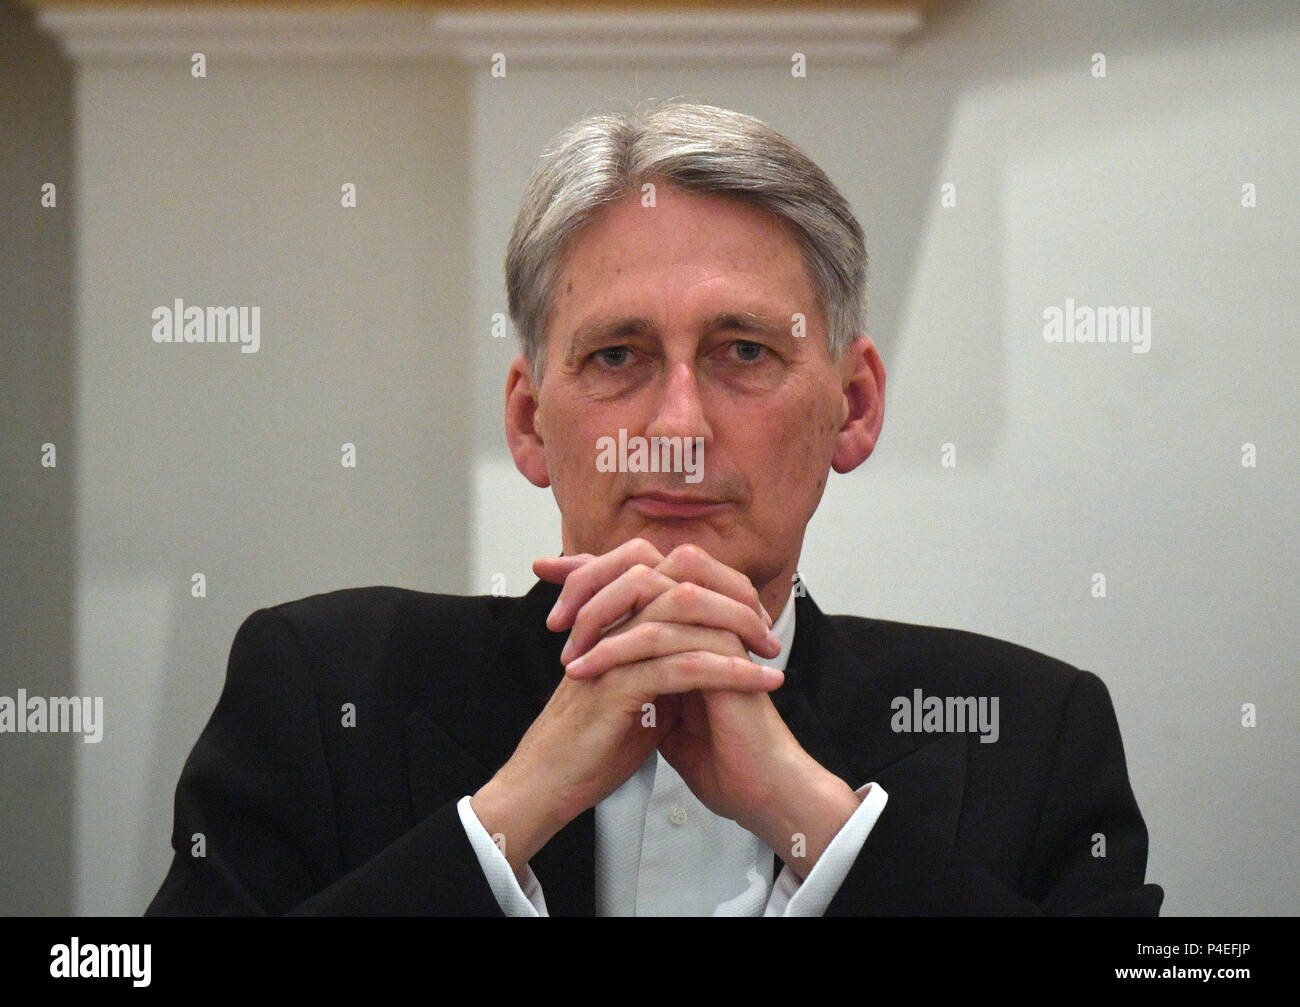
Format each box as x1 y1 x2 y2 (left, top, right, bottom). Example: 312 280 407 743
150 103 1162 915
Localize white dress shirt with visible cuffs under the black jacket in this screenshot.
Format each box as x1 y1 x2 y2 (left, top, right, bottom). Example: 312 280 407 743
456 593 889 916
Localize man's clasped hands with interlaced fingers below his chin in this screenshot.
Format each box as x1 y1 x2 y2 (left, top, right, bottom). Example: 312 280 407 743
472 539 859 878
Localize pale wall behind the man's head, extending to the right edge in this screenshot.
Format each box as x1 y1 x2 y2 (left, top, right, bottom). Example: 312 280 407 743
473 0 1300 915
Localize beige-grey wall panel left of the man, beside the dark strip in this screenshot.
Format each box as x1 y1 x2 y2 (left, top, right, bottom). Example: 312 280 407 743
65 58 469 913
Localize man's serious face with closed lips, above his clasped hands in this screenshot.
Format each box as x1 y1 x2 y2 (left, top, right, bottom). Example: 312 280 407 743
507 185 884 605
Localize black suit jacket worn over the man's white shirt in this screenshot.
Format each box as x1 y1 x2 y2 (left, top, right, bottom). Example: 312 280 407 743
148 582 1164 916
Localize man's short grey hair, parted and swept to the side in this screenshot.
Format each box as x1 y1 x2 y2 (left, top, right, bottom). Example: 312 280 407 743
506 99 867 383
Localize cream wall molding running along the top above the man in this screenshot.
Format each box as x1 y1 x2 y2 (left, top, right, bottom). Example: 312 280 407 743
36 4 923 65
